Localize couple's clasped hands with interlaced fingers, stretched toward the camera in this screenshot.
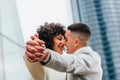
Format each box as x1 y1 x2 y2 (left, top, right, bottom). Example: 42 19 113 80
25 35 47 62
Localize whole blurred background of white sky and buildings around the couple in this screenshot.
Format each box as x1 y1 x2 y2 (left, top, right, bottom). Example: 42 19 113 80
0 0 120 80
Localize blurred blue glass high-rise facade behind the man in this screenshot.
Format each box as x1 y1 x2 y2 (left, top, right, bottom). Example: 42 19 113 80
71 0 120 80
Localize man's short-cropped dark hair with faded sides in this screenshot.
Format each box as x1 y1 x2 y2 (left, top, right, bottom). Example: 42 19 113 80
68 23 91 39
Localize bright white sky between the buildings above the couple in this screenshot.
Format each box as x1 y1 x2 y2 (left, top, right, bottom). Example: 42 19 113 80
16 0 73 41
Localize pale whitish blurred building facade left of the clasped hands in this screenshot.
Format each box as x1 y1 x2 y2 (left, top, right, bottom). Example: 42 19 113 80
0 0 30 80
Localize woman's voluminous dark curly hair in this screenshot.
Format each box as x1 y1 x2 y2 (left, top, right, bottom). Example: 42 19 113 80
37 23 65 49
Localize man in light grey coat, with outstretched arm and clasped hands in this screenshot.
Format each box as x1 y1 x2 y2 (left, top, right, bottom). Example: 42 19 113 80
26 23 102 80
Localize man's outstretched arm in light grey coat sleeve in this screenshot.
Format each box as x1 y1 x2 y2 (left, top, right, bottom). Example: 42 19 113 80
41 50 90 74
